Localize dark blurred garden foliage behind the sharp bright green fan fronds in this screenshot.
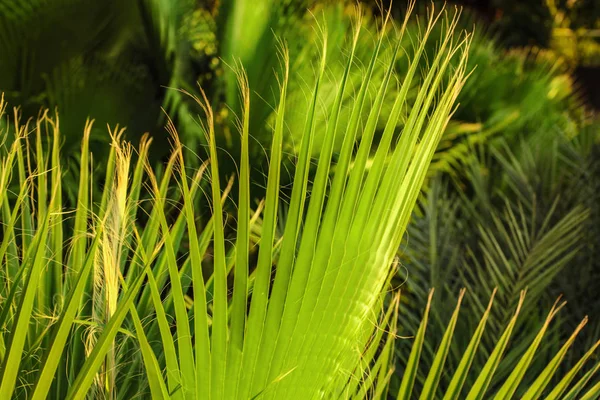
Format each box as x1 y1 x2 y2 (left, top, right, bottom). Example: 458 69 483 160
0 0 600 396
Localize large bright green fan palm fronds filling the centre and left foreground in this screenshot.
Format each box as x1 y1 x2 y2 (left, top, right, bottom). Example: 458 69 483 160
0 4 469 399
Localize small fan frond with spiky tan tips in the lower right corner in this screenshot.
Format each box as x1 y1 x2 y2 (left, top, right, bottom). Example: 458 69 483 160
397 290 600 400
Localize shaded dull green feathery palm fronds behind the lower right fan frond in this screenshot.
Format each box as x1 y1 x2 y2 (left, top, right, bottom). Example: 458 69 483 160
397 125 600 394
